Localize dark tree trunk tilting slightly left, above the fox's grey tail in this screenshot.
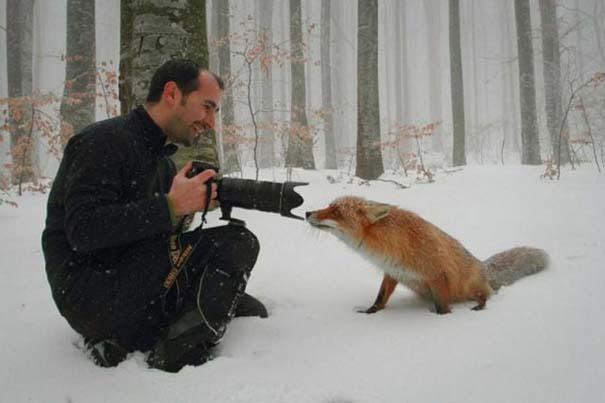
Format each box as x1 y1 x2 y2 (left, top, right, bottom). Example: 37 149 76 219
515 0 542 165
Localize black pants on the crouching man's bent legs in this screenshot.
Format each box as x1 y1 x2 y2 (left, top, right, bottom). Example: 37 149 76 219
114 225 259 351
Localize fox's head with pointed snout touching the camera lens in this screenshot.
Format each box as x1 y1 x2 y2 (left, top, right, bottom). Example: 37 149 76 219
305 196 393 238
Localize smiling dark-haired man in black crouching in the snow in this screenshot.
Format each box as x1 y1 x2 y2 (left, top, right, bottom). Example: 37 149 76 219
42 60 267 372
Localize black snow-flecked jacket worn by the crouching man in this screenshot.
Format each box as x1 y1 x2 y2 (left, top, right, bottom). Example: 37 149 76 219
42 107 175 344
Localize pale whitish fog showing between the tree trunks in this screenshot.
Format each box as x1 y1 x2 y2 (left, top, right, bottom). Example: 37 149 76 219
0 0 605 177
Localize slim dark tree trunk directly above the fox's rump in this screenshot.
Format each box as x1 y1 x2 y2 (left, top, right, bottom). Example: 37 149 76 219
449 0 466 166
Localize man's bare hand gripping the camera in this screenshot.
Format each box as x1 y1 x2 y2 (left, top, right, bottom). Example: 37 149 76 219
168 161 216 217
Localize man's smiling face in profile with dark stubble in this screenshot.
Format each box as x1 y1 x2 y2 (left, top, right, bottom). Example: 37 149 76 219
166 71 221 146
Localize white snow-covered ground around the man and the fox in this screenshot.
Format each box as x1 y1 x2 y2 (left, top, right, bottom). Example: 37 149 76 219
0 165 605 403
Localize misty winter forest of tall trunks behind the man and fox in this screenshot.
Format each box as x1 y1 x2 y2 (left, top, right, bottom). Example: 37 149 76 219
0 0 605 199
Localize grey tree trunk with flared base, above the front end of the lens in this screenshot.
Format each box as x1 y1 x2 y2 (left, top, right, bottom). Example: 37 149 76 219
286 0 315 169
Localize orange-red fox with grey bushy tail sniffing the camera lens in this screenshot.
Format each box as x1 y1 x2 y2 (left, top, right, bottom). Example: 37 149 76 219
305 196 549 314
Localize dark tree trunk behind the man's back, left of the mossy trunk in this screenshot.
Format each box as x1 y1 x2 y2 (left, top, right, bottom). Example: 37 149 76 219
61 0 97 140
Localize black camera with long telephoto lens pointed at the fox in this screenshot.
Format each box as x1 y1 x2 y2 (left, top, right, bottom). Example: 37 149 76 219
186 161 308 221
